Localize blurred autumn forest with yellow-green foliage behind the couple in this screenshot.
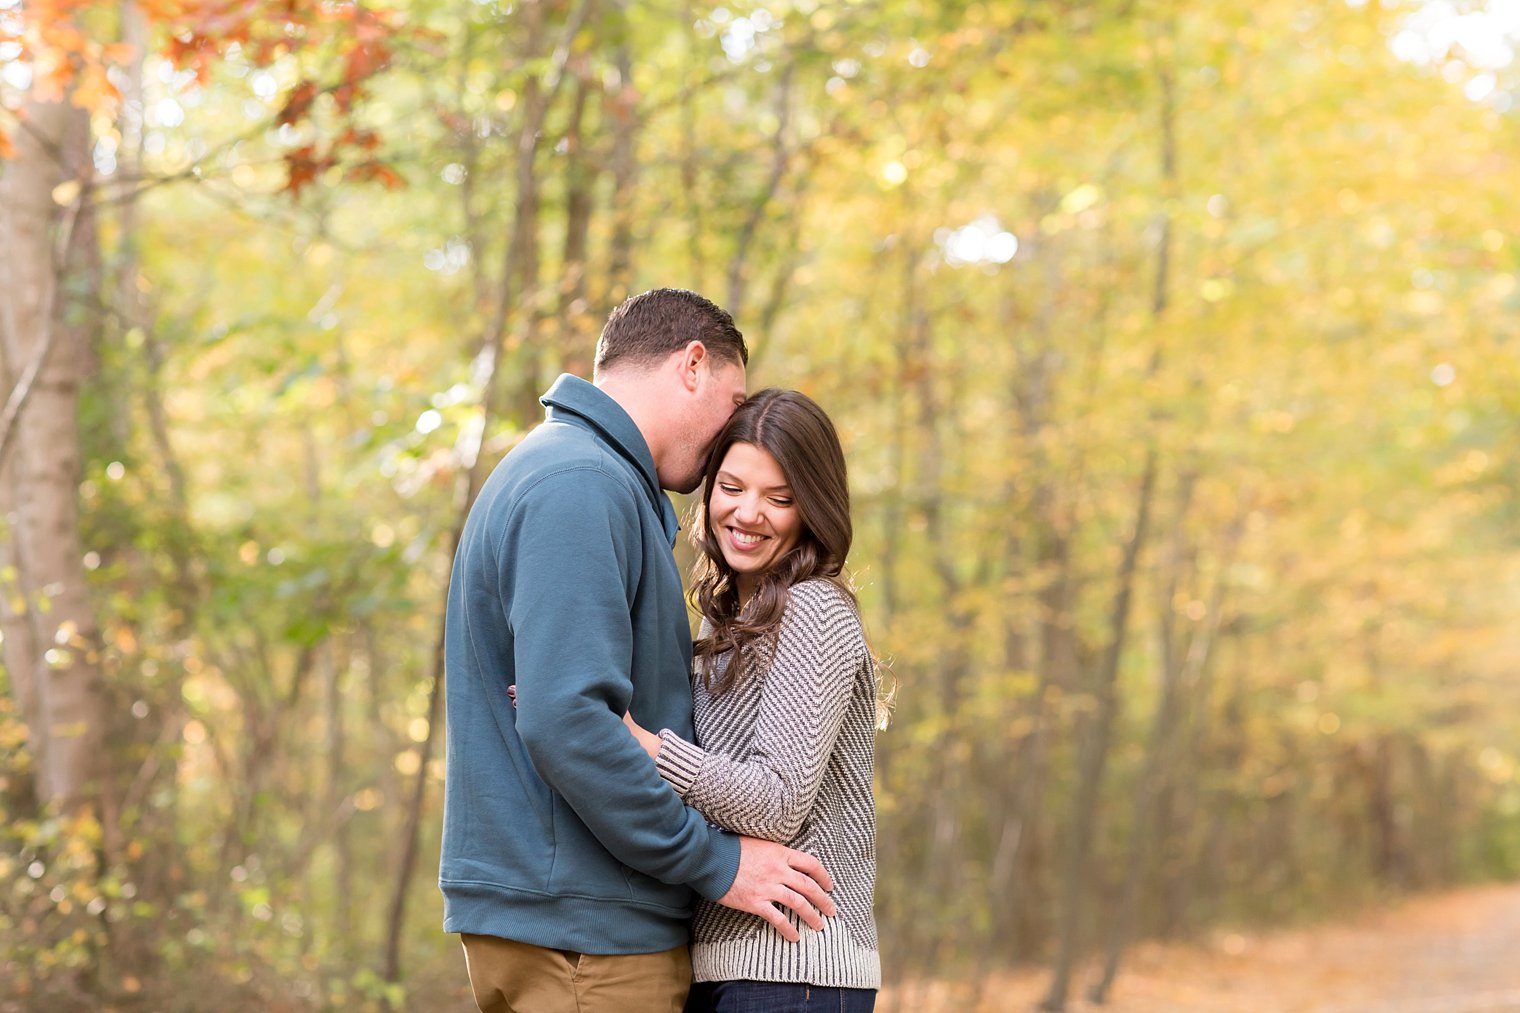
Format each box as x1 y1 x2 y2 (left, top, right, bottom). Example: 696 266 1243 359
0 0 1520 1010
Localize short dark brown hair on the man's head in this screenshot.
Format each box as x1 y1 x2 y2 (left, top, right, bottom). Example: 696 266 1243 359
594 289 749 376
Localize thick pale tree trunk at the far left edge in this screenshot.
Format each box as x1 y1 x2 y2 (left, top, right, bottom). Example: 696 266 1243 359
0 94 106 818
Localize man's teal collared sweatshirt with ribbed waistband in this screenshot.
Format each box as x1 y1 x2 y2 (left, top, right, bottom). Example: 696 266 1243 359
439 376 739 954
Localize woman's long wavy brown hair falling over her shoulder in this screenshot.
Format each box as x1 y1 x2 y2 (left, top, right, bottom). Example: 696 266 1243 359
692 388 854 694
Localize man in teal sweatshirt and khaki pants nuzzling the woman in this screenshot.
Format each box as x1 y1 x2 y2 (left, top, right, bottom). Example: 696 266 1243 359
439 289 834 1013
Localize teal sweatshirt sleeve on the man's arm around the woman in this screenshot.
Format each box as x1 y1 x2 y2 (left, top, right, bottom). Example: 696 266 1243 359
497 468 739 899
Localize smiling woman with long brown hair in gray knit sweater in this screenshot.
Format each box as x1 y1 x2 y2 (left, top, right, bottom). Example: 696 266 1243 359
628 389 882 1013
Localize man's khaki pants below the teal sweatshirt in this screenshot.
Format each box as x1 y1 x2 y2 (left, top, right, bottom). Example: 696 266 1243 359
459 934 692 1013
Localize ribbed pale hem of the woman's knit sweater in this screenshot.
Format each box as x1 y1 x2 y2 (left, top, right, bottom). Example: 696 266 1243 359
692 919 882 989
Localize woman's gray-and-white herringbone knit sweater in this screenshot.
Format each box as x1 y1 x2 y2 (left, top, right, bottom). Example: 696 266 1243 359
655 580 882 989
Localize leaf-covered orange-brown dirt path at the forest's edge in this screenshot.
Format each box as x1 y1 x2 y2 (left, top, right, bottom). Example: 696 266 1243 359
883 884 1520 1013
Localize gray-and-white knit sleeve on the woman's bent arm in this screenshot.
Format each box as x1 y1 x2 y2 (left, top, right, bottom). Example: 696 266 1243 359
655 581 869 843
